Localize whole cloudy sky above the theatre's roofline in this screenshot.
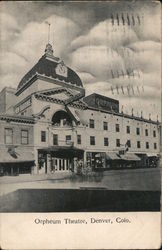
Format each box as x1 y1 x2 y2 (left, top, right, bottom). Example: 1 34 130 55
0 1 161 120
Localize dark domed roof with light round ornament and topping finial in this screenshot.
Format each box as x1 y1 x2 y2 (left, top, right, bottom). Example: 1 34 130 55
17 44 83 90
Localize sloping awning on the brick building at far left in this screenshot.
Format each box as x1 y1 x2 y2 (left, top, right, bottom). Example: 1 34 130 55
0 148 34 163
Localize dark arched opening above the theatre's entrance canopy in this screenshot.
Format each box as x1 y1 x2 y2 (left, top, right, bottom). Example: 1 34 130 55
52 110 72 126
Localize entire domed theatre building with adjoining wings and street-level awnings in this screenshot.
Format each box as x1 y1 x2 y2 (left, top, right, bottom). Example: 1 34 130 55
0 44 160 175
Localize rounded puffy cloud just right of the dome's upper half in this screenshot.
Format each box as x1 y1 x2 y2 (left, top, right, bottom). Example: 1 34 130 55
71 45 124 80
